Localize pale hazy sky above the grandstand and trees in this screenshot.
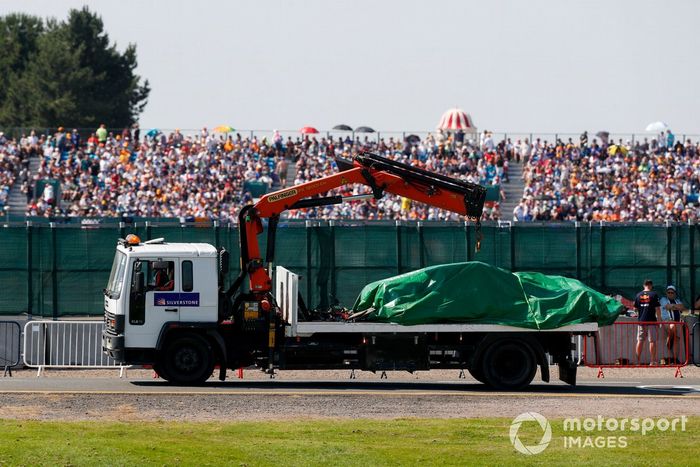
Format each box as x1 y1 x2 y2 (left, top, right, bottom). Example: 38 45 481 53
0 0 700 135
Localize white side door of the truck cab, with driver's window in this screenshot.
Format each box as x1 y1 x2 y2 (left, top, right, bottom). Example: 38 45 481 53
125 258 181 348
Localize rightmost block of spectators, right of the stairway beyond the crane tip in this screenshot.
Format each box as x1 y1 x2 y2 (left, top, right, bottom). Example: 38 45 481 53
507 130 700 222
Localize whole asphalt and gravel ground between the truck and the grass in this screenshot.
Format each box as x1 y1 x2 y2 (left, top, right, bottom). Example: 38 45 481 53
0 369 700 421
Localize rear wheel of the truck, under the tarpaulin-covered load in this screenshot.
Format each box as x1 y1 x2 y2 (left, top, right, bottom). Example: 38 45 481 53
481 339 537 390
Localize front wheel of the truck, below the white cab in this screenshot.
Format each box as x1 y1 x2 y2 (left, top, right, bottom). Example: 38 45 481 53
162 334 214 384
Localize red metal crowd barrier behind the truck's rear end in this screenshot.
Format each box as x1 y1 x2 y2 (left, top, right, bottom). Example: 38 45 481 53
583 321 692 378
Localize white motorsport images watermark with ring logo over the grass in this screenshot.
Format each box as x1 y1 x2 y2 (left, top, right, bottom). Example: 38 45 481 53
509 412 688 456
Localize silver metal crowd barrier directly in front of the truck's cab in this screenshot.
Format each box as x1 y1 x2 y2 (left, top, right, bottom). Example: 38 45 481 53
23 321 127 378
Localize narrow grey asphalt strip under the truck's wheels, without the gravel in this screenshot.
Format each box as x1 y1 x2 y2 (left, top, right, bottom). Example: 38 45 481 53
0 372 700 399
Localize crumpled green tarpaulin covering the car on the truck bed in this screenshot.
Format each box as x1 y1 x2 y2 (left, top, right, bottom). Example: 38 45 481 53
353 261 623 329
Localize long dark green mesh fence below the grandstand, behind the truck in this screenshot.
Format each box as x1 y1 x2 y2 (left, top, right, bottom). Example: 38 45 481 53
0 220 700 317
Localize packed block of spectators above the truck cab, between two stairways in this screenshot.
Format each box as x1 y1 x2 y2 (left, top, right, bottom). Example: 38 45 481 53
27 128 275 221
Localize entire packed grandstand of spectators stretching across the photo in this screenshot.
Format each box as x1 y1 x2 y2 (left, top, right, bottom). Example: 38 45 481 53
0 127 700 222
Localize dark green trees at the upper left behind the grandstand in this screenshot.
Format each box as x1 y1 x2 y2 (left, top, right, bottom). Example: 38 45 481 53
0 7 150 128
